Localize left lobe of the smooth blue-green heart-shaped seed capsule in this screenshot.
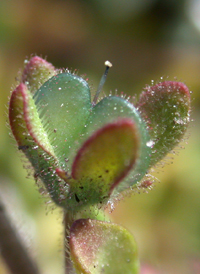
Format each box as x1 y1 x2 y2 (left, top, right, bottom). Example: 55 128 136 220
34 73 91 168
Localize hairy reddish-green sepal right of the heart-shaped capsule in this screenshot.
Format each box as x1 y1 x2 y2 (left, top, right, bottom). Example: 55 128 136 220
137 81 191 165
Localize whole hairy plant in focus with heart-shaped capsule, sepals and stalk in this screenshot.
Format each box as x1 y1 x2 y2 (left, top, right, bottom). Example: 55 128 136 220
9 56 191 274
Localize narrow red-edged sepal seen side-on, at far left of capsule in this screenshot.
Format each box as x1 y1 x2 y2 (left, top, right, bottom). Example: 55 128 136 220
9 83 67 206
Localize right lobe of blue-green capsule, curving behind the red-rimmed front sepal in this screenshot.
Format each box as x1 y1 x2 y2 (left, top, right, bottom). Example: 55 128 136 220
84 96 151 192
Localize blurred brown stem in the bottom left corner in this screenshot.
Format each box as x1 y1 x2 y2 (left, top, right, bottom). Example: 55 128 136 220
0 201 40 274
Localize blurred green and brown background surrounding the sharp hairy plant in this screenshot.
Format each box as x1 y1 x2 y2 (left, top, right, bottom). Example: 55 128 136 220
0 0 200 274
